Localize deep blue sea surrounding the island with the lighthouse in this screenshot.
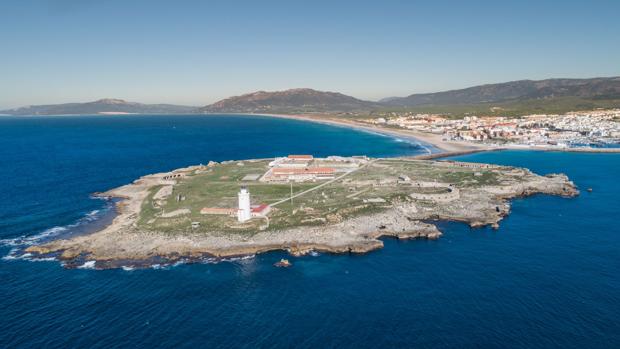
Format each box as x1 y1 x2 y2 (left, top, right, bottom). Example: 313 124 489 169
0 116 620 348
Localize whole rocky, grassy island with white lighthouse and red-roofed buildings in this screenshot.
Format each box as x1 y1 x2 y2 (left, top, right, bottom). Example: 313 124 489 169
26 155 579 269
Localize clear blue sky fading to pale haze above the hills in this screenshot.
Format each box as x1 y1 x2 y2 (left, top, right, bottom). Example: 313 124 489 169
0 0 620 108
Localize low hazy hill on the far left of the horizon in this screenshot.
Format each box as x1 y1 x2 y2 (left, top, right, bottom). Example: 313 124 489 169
0 99 196 115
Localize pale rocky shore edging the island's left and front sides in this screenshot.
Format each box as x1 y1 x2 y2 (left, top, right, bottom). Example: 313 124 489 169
26 158 579 269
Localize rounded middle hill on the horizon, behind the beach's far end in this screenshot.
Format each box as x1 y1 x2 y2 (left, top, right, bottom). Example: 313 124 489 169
199 88 382 113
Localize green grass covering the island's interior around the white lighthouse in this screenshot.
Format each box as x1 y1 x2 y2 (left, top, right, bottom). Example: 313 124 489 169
138 159 512 236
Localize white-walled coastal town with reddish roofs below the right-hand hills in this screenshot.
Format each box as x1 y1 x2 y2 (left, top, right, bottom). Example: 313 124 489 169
360 109 620 148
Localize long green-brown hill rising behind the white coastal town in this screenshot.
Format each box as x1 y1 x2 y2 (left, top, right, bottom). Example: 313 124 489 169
380 77 620 107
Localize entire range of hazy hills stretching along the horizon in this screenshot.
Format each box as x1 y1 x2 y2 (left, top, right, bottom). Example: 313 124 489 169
0 77 620 115
